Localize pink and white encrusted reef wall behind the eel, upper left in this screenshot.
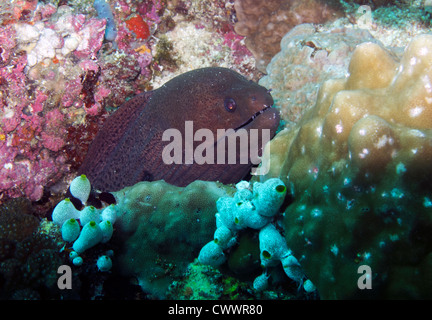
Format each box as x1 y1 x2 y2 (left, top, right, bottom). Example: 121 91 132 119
0 0 253 202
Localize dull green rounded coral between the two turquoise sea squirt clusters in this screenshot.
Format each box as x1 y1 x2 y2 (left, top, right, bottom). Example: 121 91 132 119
109 181 233 298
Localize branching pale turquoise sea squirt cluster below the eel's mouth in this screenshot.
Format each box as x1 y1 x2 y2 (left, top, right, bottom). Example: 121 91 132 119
198 178 305 291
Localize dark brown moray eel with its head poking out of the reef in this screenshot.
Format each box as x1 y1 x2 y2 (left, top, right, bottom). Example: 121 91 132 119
78 67 279 192
